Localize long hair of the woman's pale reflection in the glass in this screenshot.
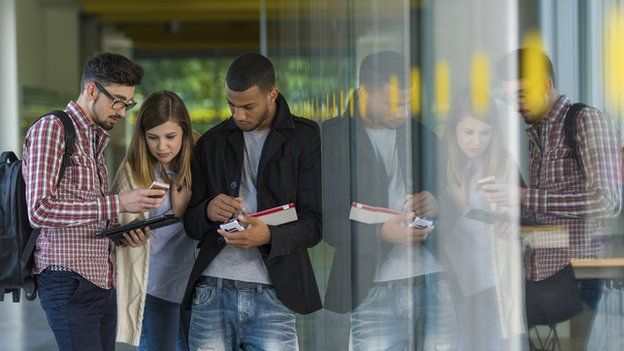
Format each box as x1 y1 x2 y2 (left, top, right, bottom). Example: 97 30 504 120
442 91 508 185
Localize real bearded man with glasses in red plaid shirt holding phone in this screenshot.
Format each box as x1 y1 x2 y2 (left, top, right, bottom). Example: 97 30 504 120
22 53 163 350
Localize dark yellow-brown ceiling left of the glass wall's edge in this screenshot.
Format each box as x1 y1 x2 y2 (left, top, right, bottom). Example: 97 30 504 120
72 0 260 51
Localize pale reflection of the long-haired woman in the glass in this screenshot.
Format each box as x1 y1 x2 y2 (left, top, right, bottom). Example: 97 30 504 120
440 94 523 351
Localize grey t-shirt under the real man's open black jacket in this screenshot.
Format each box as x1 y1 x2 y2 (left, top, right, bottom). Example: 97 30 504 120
203 129 271 284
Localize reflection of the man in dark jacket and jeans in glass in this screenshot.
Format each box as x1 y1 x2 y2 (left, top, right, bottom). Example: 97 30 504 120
322 52 452 350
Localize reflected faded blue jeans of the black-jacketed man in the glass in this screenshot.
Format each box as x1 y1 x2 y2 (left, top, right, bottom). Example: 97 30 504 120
351 274 457 351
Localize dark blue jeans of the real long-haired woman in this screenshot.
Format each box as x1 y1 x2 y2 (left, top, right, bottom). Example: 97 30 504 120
137 294 186 351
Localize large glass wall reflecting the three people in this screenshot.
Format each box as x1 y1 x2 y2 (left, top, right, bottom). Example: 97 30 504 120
267 0 624 350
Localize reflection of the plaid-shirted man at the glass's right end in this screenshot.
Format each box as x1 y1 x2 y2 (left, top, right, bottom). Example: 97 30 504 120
494 48 622 338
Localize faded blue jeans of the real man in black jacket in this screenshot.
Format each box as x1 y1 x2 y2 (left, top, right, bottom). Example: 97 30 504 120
189 278 297 351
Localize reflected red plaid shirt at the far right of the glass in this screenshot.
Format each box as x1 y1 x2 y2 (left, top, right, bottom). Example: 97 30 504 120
523 95 622 280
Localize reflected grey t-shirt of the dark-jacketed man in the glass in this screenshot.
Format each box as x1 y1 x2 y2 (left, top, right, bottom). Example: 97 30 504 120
366 128 440 282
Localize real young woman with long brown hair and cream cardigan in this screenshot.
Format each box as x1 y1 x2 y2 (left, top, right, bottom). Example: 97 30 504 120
113 91 195 351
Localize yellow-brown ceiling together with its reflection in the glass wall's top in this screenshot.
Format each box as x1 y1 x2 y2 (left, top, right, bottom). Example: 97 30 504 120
67 0 420 53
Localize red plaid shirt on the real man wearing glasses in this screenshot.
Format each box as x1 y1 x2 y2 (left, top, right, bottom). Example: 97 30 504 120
22 101 119 289
